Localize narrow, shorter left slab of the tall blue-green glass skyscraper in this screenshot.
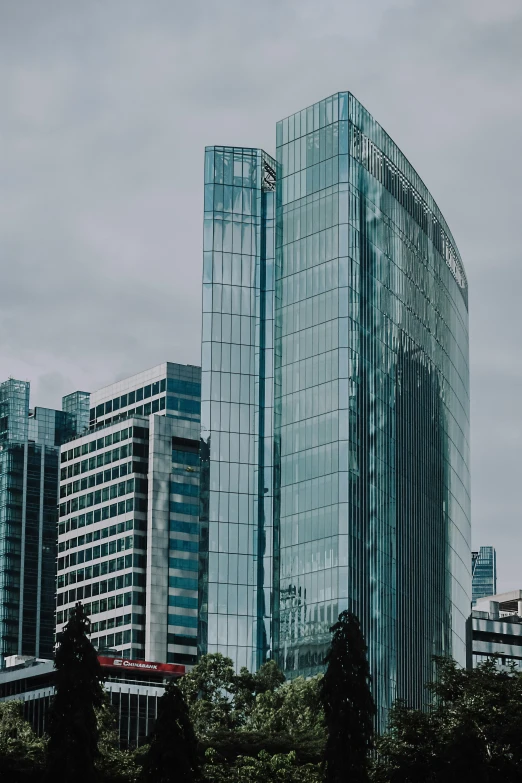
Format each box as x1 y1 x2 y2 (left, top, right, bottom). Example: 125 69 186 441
199 147 276 669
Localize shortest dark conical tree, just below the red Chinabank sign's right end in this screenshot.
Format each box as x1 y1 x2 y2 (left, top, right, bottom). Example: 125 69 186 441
141 681 200 783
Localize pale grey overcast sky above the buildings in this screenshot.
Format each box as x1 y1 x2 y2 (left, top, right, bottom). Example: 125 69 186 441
0 0 522 590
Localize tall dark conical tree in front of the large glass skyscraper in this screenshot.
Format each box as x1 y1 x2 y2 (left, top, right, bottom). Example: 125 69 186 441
321 611 375 783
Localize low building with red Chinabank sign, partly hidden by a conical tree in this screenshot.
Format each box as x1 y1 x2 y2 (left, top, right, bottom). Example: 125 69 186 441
0 656 185 748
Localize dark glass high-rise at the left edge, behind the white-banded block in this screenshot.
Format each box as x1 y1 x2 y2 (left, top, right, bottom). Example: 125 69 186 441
0 378 75 667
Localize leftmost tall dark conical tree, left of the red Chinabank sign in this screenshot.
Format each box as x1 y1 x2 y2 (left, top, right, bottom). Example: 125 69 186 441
47 603 103 783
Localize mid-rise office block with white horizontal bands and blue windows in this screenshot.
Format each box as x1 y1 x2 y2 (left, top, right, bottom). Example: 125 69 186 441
56 362 201 664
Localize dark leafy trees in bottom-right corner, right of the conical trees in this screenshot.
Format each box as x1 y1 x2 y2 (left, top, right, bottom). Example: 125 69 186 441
372 658 522 783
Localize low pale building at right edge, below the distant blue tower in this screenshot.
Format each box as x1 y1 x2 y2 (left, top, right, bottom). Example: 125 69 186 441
472 590 522 668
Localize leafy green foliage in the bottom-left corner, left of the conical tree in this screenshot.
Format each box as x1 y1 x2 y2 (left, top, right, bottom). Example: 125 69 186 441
0 701 45 783
